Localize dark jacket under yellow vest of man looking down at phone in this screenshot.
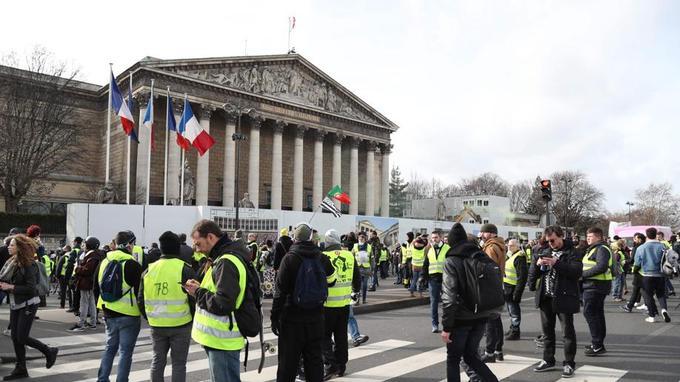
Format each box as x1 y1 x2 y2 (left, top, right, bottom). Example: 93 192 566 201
194 235 250 316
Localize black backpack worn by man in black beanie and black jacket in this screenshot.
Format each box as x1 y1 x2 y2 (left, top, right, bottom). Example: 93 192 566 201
461 251 505 313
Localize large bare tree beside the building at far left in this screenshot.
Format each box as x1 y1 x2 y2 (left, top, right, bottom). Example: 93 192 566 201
0 48 81 212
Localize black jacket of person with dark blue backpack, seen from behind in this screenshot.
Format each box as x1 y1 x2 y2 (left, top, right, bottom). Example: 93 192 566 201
271 241 335 322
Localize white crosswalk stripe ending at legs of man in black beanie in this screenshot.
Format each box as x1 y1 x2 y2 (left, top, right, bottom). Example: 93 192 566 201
333 346 446 382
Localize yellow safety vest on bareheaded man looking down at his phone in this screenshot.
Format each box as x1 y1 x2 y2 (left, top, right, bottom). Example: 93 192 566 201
191 254 246 350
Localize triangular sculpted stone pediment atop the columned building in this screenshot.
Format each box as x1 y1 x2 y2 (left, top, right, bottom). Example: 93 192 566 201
144 54 397 130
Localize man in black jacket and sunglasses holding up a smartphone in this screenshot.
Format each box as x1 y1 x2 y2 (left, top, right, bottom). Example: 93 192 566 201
529 226 583 378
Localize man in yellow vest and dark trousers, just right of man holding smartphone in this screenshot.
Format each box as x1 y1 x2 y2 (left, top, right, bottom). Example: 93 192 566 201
581 227 613 357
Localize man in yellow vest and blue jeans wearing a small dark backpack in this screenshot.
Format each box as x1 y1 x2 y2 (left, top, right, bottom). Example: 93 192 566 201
97 231 142 381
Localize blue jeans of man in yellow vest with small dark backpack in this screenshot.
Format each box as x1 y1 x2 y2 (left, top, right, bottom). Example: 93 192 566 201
97 316 141 382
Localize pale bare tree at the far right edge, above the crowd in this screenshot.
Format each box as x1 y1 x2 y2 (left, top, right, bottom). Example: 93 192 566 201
634 183 680 228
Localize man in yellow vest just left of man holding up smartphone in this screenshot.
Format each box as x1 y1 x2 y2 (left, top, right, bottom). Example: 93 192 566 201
503 239 529 341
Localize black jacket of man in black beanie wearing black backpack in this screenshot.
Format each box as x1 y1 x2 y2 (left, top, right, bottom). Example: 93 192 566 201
442 241 491 332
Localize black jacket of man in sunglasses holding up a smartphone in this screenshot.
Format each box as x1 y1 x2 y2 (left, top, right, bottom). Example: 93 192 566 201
529 240 583 313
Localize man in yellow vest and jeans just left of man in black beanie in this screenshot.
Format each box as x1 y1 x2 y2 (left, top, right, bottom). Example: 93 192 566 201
423 231 450 333
